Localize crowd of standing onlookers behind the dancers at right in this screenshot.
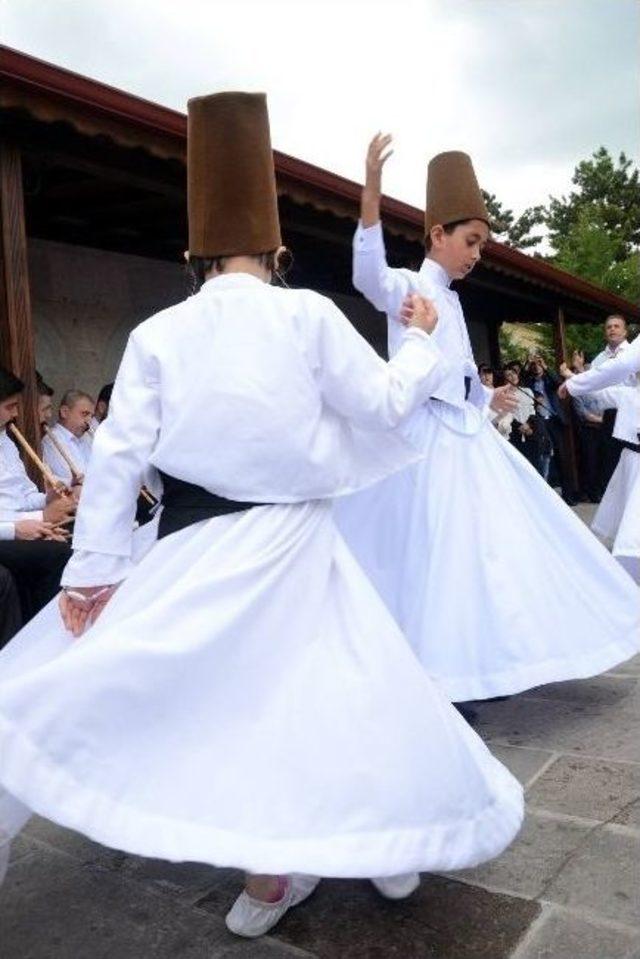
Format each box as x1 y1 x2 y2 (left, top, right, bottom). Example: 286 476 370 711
478 316 634 504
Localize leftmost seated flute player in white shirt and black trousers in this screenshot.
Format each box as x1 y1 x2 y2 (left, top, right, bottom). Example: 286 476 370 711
0 367 75 622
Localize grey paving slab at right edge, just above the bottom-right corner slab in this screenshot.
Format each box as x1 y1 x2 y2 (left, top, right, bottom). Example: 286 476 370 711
544 826 640 934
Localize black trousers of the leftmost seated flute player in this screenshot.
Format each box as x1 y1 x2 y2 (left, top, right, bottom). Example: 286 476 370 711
0 539 71 623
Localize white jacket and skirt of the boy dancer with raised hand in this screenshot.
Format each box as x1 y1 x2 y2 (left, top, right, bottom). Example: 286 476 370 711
335 225 640 701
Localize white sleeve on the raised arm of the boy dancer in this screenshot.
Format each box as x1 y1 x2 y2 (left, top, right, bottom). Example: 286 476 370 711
353 223 409 320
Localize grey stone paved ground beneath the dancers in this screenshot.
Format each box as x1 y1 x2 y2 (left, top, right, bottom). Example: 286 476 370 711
0 506 640 959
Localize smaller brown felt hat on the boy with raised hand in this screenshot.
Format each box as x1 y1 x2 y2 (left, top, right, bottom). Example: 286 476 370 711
424 150 489 236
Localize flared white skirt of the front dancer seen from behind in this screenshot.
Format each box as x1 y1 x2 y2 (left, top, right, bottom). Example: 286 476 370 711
0 503 522 877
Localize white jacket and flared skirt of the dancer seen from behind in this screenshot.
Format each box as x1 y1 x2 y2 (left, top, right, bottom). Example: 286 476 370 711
0 275 522 876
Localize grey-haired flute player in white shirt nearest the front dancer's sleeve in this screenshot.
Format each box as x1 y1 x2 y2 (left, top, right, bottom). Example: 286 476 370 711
42 390 95 486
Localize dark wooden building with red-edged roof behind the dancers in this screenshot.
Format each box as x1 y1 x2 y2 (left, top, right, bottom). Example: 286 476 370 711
0 47 640 480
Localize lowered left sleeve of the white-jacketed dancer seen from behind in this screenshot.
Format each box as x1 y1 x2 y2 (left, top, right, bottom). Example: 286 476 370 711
63 333 160 586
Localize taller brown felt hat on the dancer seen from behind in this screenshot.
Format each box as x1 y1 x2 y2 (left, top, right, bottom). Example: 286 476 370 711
187 93 282 257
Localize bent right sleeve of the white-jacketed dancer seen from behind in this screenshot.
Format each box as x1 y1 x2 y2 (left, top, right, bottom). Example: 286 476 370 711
314 297 446 430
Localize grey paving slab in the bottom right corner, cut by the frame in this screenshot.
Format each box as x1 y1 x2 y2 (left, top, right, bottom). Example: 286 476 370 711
511 906 638 959
